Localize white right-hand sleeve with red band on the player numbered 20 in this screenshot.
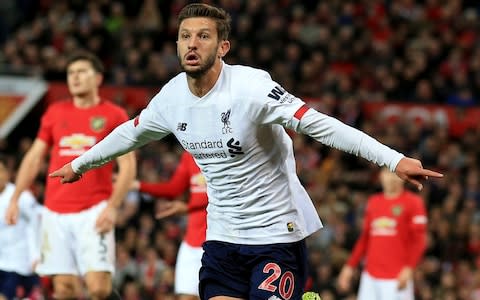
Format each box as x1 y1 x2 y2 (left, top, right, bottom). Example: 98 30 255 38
244 73 404 172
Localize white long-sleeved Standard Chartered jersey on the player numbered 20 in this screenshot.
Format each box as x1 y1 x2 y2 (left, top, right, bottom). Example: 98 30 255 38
72 64 403 244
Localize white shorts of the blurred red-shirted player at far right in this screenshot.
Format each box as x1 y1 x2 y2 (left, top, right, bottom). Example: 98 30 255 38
357 271 414 300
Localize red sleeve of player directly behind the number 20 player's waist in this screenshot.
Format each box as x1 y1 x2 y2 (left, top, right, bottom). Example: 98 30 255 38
140 153 190 198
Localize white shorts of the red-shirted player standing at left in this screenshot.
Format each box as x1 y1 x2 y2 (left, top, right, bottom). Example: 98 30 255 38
36 201 115 276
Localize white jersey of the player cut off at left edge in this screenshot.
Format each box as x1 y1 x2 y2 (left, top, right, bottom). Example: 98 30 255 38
0 183 41 276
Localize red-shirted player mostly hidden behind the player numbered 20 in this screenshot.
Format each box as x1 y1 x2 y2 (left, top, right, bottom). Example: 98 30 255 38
133 152 208 300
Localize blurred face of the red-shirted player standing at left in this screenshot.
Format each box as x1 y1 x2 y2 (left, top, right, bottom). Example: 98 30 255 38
67 60 101 96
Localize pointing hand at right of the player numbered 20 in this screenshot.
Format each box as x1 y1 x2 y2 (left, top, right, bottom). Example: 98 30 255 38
395 157 443 191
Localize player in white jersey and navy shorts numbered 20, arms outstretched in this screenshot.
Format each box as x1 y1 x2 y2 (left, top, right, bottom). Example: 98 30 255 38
50 3 442 300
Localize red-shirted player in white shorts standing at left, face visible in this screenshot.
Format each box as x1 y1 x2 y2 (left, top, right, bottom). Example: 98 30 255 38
6 52 136 299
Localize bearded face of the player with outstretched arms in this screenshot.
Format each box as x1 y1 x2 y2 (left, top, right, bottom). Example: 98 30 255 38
177 17 230 78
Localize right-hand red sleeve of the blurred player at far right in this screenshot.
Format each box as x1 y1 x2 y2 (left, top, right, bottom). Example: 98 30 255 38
407 195 427 268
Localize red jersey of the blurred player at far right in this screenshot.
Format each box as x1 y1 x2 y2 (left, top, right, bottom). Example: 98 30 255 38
347 191 427 279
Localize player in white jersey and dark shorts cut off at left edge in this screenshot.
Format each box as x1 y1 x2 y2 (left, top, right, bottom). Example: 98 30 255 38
0 155 41 299
